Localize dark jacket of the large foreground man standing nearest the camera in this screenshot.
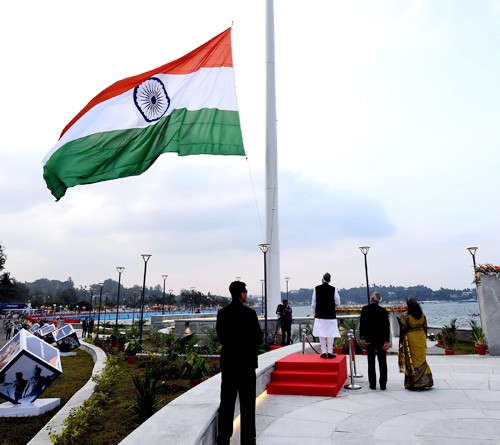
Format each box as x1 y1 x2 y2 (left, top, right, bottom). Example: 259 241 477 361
216 300 262 371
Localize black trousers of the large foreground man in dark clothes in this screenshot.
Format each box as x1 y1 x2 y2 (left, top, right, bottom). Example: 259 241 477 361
217 369 256 445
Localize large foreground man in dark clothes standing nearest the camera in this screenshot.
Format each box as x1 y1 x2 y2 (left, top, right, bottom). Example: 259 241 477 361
216 281 262 445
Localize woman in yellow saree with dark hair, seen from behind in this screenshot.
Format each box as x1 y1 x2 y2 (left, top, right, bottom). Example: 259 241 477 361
398 297 434 391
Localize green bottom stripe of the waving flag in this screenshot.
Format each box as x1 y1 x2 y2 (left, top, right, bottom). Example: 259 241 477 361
43 109 245 200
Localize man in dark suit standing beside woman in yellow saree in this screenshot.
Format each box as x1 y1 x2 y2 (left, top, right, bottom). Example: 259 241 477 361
359 292 391 390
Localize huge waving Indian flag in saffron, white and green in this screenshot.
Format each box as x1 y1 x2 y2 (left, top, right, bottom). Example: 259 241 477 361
43 28 245 200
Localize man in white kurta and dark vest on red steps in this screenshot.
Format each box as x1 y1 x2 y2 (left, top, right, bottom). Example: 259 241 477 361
311 272 340 358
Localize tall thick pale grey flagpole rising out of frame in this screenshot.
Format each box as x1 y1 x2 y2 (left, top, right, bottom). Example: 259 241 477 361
265 0 281 315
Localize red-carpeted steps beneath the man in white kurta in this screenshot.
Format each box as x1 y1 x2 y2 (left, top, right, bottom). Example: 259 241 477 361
267 354 347 397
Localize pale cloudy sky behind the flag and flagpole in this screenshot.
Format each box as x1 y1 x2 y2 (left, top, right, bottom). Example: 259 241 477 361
0 0 500 295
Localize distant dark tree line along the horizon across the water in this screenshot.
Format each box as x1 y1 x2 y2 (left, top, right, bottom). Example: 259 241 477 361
0 239 476 311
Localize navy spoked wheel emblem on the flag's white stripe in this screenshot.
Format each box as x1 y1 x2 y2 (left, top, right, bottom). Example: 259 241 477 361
134 77 170 122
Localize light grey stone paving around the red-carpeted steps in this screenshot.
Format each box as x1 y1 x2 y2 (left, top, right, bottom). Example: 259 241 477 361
231 344 500 445
